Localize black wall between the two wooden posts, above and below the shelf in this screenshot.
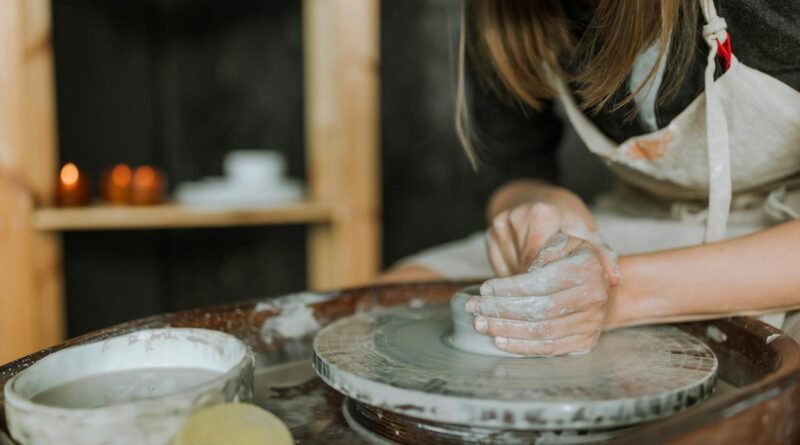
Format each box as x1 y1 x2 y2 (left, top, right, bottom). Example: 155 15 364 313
52 0 306 335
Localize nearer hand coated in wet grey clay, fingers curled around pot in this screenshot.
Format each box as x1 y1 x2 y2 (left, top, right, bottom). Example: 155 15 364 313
467 234 620 356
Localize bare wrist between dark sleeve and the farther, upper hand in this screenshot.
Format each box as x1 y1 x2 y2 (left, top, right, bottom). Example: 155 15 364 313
486 180 596 230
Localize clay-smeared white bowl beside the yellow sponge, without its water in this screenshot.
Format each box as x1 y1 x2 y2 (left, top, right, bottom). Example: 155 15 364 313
5 328 254 445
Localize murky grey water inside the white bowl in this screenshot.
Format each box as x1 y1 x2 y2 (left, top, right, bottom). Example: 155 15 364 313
31 368 222 409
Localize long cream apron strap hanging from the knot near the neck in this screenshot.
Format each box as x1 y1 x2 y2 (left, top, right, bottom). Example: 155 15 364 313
700 0 731 242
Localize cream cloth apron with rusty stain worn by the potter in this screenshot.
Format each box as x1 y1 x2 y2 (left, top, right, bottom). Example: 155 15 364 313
402 0 800 332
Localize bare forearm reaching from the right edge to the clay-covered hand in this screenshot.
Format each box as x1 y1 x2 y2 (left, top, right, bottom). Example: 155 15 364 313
609 221 800 328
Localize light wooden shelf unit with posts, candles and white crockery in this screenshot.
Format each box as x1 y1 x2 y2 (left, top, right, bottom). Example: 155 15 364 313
0 0 380 363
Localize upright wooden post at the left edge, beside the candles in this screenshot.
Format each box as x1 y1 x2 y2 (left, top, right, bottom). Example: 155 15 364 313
0 0 64 362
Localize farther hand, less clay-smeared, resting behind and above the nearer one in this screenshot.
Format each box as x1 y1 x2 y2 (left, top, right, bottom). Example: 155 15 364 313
488 198 599 277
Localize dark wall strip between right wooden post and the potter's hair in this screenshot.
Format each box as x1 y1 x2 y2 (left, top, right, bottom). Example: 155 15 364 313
381 0 491 264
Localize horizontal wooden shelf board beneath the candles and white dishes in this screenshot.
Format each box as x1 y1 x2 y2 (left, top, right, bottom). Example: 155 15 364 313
33 202 331 231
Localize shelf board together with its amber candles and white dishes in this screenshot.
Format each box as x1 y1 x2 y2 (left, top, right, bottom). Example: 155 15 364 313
45 150 306 231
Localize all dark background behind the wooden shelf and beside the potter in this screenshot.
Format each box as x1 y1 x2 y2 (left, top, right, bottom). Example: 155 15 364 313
52 0 598 336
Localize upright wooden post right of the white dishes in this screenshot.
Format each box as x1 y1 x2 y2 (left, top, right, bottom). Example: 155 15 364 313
303 0 381 289
